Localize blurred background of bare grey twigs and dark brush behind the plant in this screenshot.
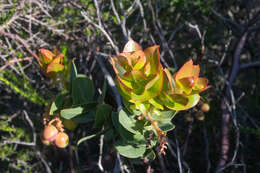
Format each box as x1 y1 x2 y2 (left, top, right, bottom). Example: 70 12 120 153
0 0 260 173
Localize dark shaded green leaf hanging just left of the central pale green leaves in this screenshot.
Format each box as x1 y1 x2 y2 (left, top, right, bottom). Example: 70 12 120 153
94 104 112 128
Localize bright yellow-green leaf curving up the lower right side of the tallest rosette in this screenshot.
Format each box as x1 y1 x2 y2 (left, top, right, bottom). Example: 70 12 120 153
130 70 163 103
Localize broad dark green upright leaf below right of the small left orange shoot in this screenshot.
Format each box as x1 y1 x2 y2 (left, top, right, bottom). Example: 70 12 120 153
72 75 94 104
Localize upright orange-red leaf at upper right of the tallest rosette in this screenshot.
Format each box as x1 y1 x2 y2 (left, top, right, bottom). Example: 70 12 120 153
144 45 161 74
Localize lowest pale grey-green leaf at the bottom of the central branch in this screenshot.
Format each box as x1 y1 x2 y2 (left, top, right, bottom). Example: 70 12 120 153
115 140 146 158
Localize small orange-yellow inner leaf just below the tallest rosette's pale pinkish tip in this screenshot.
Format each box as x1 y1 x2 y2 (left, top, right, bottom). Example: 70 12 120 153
131 50 146 70
